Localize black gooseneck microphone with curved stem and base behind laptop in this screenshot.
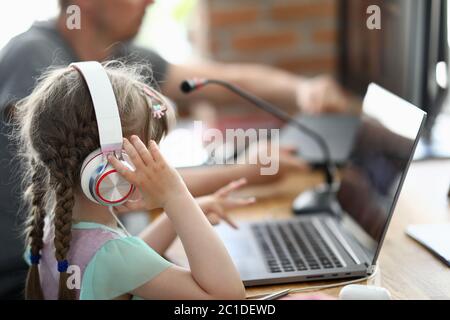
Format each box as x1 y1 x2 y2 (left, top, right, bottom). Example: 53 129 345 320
180 78 336 213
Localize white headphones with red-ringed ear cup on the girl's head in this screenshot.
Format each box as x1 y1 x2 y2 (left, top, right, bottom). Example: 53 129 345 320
70 61 134 206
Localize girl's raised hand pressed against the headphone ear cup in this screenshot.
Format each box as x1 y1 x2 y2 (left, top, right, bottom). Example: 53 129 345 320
108 135 189 208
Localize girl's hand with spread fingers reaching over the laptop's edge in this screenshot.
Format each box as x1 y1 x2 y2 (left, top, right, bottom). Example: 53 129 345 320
196 178 255 229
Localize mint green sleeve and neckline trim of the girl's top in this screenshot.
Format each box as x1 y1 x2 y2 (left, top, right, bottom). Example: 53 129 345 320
73 222 172 300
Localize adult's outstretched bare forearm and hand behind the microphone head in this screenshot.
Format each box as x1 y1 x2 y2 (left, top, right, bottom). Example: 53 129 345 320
162 62 348 113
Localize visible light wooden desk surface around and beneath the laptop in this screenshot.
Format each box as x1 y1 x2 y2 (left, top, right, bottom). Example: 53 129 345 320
168 161 450 299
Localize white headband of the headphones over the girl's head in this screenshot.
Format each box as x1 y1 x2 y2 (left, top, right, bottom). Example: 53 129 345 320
70 61 123 154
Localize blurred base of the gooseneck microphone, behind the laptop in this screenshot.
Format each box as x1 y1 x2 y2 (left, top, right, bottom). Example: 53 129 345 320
292 183 340 214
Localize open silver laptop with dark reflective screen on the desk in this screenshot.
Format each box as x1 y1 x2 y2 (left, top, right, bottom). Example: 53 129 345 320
216 84 426 286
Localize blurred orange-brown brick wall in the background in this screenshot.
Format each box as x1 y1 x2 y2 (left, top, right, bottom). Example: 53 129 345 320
201 0 338 75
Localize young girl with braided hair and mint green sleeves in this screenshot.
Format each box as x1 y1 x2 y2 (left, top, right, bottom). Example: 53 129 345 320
16 63 253 299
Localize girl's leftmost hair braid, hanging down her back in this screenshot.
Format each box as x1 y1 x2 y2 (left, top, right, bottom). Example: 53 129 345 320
25 159 47 300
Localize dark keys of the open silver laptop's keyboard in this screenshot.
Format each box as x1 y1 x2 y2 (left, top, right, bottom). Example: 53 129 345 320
251 221 342 273
